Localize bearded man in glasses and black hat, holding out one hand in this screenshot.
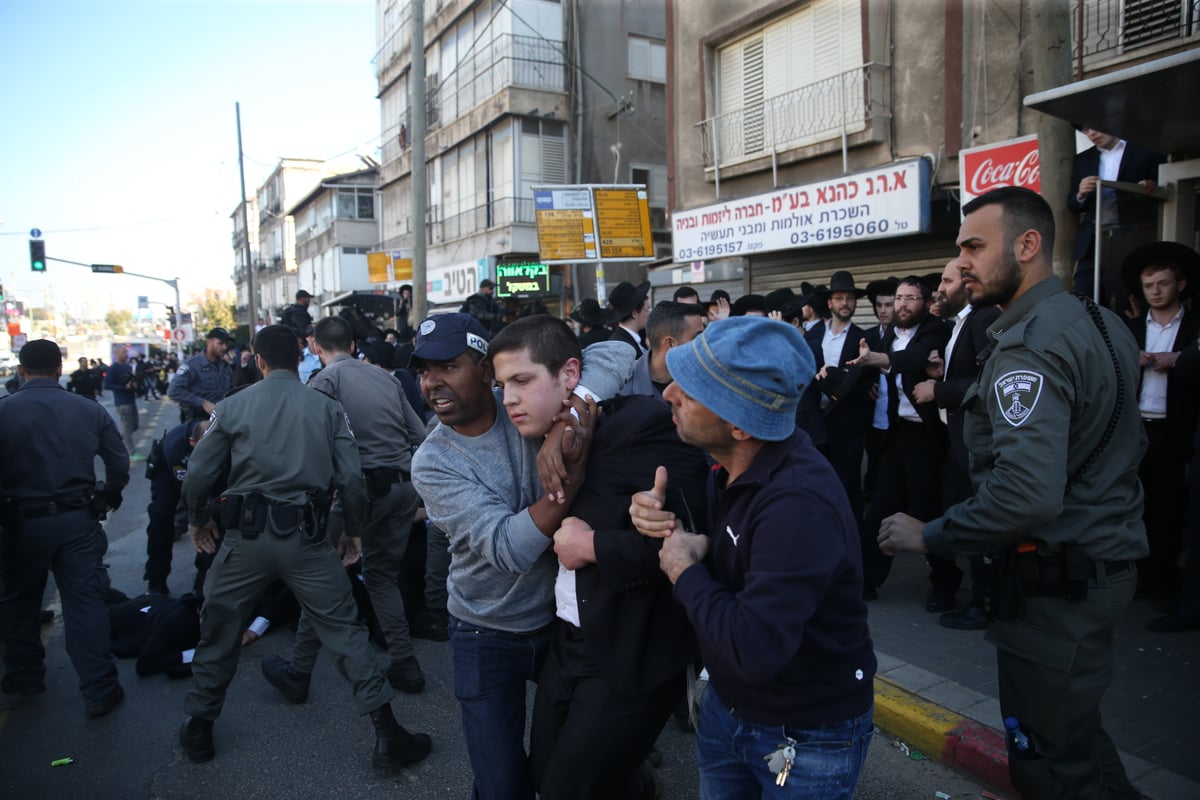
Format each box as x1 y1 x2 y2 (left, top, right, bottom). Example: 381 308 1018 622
847 275 962 599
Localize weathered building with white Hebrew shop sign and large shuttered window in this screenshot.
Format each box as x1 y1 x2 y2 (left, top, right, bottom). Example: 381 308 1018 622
667 0 1200 296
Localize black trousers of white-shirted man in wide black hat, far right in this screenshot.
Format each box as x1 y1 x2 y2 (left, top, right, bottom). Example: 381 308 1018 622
1138 420 1188 595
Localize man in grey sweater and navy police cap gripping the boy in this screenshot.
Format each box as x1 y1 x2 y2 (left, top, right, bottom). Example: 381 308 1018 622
412 314 632 800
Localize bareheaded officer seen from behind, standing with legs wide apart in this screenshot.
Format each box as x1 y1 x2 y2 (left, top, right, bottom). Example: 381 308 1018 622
180 325 431 769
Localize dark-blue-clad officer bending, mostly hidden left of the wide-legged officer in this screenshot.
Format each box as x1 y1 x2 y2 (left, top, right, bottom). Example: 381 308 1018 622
142 420 209 595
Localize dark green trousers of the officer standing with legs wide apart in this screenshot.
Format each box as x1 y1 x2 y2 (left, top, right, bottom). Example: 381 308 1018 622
184 530 395 720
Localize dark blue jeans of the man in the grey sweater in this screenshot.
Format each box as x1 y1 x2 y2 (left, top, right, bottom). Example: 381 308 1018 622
450 616 550 800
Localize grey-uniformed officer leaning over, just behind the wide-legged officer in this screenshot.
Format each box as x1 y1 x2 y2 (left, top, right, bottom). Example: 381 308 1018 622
262 317 425 696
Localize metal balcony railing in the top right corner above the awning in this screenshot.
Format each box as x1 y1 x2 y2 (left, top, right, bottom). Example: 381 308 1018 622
1072 0 1200 75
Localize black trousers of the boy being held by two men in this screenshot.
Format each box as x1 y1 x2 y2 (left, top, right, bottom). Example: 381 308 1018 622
529 620 686 800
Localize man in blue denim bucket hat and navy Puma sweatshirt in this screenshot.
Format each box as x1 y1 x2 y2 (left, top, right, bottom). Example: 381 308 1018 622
630 317 875 800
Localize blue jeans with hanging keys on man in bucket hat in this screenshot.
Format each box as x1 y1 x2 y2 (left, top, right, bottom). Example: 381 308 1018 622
696 685 875 800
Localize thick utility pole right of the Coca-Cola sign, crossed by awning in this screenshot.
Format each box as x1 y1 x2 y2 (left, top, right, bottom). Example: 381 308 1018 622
1030 2 1079 288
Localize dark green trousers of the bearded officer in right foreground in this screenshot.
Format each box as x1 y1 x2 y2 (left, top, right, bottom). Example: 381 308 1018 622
988 565 1140 800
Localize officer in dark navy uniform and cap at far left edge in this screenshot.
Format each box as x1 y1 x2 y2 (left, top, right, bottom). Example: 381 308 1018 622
0 339 130 717
